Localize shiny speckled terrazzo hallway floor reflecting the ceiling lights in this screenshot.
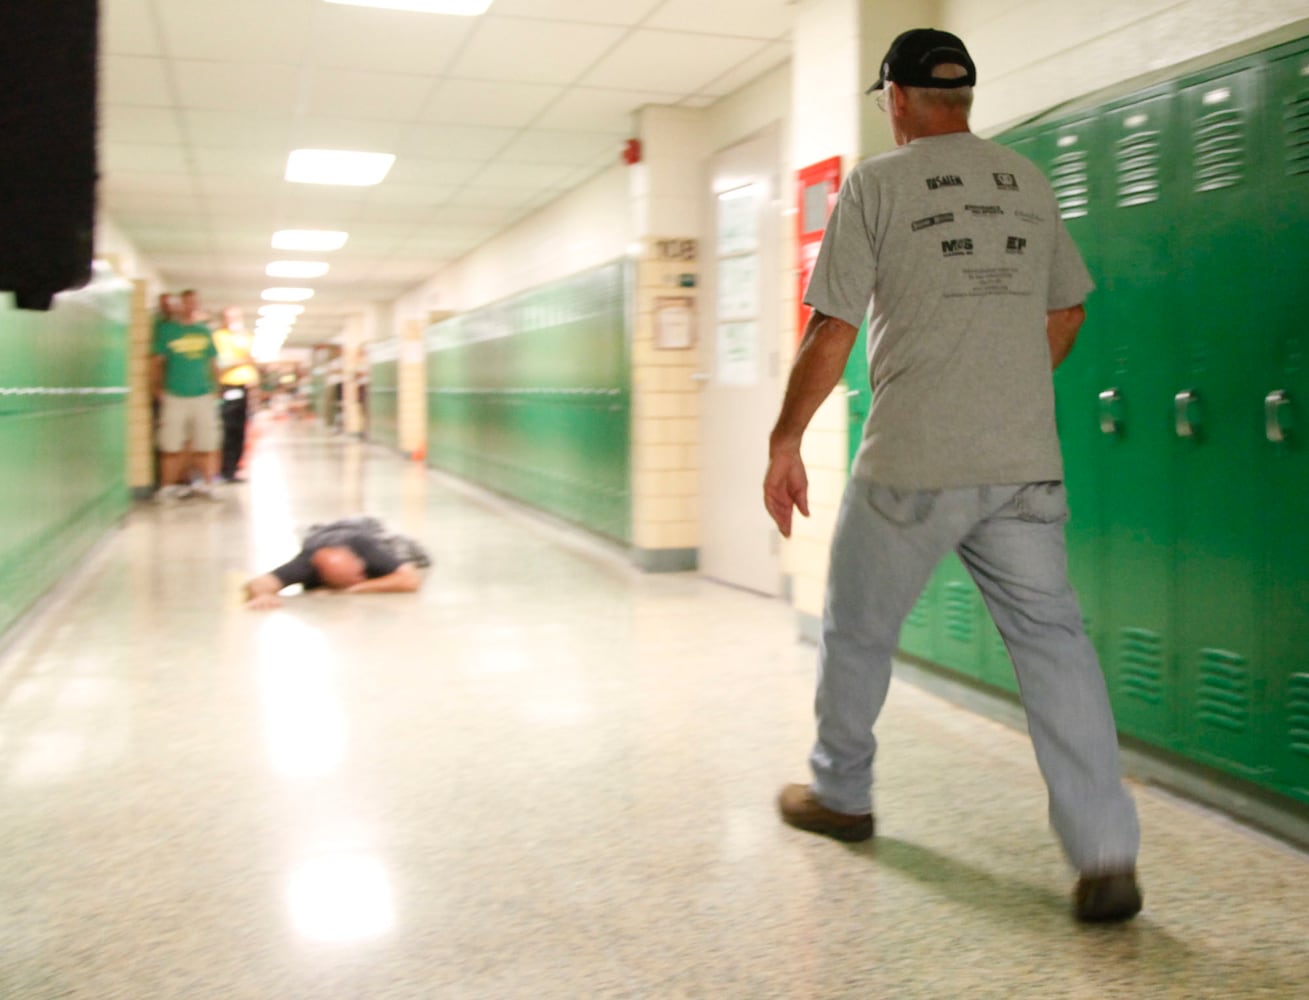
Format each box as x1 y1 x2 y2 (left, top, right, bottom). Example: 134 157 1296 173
0 428 1309 1000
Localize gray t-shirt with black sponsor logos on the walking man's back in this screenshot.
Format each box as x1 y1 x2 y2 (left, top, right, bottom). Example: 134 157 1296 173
805 132 1094 490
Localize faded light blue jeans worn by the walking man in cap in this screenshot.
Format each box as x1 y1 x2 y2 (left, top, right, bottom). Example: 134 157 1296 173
809 479 1140 873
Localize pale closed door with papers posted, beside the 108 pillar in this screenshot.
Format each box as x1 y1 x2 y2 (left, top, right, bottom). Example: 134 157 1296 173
700 126 789 594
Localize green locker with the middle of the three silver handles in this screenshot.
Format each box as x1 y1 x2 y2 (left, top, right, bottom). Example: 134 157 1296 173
1169 65 1274 777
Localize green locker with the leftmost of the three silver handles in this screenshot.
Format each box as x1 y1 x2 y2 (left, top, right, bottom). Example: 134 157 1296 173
1089 90 1182 746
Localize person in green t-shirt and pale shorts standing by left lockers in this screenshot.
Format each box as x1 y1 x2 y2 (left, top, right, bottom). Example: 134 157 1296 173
151 291 223 503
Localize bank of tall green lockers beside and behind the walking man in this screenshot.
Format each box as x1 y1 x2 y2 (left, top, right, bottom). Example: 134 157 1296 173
864 39 1309 802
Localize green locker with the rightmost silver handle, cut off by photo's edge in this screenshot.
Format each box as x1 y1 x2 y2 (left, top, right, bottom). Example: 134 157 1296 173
1251 43 1309 801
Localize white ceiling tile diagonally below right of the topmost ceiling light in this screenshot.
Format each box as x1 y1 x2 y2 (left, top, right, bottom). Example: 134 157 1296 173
449 18 624 84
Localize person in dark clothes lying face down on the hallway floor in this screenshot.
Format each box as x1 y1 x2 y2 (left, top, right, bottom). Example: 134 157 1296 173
245 517 432 611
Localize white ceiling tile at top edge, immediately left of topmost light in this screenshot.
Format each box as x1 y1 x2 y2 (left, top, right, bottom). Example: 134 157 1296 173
154 0 315 65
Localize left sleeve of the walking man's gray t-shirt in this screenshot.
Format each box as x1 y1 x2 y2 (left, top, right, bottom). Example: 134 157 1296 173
805 174 877 327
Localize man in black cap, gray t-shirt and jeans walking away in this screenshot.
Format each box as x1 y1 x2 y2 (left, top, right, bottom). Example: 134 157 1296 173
764 29 1141 921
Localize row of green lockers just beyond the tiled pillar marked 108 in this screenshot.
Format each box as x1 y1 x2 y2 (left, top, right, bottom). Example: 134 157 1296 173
427 262 631 542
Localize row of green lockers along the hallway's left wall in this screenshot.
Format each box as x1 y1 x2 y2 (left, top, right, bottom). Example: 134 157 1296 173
0 274 131 632
